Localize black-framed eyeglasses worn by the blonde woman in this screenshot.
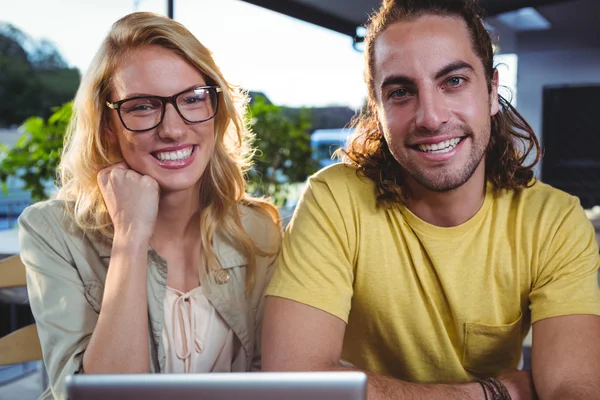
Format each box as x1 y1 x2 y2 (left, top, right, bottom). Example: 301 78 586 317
106 86 222 132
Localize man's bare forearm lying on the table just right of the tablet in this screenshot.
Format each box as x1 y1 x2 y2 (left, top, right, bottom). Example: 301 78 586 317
328 366 485 400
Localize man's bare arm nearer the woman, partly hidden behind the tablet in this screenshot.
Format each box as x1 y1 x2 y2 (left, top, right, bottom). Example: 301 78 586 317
262 296 496 400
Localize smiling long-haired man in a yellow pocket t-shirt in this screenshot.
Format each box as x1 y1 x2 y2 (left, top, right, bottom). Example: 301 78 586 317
263 0 600 400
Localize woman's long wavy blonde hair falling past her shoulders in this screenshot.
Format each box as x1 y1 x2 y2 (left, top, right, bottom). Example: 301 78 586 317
57 12 281 291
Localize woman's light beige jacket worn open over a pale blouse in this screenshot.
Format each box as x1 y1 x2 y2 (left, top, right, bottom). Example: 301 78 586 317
19 200 281 399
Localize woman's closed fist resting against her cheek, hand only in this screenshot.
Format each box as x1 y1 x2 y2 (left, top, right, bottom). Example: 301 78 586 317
97 161 160 240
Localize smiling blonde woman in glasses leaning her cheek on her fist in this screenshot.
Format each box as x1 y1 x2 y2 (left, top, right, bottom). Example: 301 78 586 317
19 13 281 398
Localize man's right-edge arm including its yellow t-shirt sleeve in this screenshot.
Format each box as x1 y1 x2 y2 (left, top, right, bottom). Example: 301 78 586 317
529 191 600 400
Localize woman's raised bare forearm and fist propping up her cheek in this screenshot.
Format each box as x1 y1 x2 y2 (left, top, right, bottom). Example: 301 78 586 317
83 162 159 374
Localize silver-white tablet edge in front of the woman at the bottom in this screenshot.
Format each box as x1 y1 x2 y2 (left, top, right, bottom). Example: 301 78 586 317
66 371 367 400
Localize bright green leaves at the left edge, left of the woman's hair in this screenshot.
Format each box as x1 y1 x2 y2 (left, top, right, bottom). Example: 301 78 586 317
0 103 73 200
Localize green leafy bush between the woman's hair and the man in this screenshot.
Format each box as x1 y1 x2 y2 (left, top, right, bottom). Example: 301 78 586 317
248 96 318 206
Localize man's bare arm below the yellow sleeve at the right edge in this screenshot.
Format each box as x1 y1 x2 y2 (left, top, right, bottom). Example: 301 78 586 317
532 315 600 400
